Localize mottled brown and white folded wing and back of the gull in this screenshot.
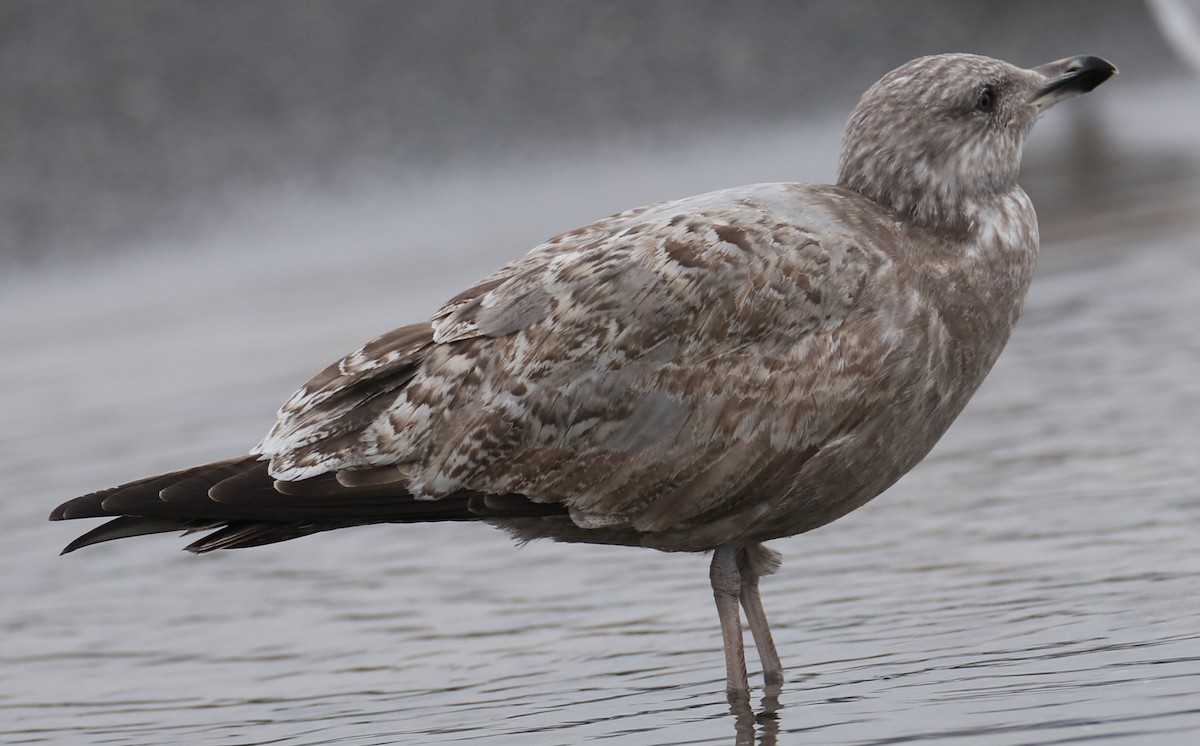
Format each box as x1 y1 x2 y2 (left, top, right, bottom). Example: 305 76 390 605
258 185 895 531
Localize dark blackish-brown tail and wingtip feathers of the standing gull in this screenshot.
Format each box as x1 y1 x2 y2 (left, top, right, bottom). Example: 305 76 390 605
50 456 565 554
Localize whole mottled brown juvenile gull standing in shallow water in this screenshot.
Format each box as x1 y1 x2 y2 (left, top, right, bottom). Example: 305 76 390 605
50 54 1116 696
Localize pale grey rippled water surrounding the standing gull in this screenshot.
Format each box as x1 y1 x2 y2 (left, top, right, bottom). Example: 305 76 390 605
0 82 1200 746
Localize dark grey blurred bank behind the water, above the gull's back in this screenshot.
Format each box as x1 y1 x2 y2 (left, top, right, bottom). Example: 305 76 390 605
0 0 1181 270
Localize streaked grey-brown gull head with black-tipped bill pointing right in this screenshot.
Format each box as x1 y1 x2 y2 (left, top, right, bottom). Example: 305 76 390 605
838 54 1116 233
